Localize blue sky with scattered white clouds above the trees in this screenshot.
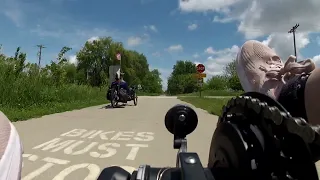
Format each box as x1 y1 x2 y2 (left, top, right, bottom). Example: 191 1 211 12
0 0 320 89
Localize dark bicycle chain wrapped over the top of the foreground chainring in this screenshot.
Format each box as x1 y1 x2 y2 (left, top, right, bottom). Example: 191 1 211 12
218 96 320 179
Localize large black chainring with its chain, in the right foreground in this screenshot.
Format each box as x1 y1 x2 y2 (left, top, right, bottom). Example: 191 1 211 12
209 93 318 180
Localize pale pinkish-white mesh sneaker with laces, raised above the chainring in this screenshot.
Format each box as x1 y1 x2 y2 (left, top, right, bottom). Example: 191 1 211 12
236 40 315 99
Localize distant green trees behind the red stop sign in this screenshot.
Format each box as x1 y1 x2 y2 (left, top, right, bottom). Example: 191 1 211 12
167 60 243 95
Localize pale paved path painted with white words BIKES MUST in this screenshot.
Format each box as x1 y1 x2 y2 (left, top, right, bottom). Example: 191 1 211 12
14 96 320 180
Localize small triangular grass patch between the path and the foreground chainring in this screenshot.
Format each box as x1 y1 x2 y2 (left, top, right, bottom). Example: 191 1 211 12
178 97 231 116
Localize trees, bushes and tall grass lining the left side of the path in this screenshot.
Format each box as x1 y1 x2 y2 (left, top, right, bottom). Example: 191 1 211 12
0 37 162 108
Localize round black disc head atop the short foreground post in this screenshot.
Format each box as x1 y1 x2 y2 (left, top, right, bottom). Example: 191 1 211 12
164 104 198 137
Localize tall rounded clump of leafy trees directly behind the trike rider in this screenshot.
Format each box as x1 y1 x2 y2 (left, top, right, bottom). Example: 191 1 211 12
77 37 162 92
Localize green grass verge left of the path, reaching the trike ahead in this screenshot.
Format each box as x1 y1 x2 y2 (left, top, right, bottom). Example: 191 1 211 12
0 84 108 121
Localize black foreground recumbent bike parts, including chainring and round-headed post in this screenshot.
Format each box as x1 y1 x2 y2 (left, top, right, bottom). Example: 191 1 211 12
98 92 320 180
